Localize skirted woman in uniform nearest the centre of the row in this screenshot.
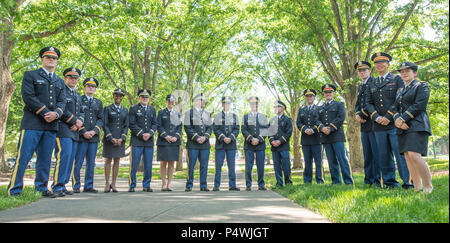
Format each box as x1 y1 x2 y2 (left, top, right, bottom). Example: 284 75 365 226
156 94 182 191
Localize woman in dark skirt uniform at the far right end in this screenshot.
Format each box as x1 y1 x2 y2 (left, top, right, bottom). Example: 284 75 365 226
394 62 433 193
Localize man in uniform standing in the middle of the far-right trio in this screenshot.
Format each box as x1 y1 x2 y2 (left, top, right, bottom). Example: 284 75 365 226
365 52 413 189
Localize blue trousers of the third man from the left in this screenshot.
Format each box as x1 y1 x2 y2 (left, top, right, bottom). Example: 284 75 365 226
72 142 98 190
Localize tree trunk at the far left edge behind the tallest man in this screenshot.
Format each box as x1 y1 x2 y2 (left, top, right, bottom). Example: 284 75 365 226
0 23 16 171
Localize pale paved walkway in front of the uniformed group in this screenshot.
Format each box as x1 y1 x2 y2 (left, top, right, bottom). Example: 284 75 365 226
0 166 330 223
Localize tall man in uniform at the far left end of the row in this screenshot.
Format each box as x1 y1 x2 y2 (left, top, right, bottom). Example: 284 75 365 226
7 47 66 197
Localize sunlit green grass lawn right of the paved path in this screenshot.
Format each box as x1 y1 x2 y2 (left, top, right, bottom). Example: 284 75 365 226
266 157 449 223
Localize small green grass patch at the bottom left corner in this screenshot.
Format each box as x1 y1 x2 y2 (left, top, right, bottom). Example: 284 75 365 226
0 186 42 210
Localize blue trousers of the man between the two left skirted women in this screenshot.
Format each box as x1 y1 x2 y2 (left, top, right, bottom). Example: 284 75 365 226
128 146 154 188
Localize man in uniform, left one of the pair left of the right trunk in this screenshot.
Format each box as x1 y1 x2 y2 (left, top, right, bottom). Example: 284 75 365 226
297 89 324 184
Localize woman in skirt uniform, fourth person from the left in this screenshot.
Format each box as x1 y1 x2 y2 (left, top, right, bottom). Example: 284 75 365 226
103 89 128 192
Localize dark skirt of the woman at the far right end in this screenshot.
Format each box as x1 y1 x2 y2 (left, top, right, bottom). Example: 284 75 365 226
397 132 430 156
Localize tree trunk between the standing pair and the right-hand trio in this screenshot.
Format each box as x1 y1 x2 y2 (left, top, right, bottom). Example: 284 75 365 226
344 84 364 169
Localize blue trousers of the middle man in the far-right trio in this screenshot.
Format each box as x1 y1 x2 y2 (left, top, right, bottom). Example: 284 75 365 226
375 129 412 188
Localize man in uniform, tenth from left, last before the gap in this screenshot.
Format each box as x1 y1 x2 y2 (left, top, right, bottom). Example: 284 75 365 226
269 100 292 187
